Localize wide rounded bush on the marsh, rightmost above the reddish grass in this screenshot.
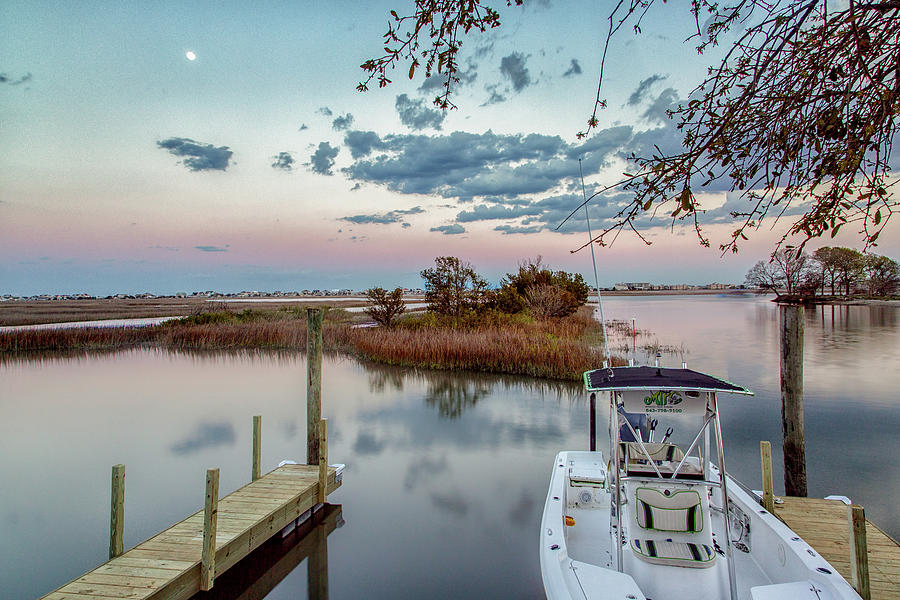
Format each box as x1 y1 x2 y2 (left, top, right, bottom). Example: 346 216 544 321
497 256 589 319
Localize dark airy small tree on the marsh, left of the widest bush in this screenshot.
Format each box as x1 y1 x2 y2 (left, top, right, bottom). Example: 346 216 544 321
420 256 489 324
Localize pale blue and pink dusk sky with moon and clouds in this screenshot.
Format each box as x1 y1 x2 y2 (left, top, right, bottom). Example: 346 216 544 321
0 0 900 295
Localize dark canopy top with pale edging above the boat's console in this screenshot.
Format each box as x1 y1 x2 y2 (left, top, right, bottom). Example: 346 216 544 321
584 367 753 396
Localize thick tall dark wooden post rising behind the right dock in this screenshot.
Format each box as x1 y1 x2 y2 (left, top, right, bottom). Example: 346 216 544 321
778 304 806 497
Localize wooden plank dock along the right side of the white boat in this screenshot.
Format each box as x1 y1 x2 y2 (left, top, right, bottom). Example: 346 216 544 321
775 496 900 600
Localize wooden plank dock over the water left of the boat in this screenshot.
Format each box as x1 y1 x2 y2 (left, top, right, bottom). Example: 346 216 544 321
38 465 341 600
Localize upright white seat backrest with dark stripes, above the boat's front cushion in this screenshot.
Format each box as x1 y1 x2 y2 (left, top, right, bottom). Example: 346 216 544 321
634 487 703 533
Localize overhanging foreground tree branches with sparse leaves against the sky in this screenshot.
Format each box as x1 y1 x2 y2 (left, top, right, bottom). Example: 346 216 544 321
357 0 900 252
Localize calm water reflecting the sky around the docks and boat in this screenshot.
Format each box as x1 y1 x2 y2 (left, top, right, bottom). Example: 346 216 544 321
0 296 900 598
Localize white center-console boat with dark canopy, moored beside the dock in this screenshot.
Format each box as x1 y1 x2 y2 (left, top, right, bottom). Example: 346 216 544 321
540 366 859 600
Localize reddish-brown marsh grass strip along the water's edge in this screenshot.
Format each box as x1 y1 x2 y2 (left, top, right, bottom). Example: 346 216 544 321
0 308 621 380
